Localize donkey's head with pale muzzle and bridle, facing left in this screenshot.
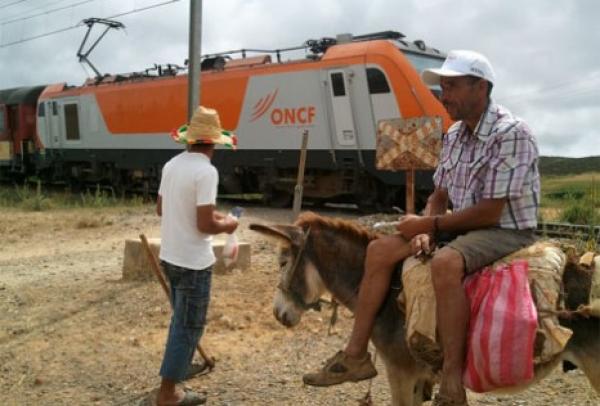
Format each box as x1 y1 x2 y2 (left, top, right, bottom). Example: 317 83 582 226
250 224 325 327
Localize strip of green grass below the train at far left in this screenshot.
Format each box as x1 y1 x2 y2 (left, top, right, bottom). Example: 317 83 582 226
0 180 144 211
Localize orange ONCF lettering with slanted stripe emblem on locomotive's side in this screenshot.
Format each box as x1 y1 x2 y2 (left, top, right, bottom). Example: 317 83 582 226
250 89 317 126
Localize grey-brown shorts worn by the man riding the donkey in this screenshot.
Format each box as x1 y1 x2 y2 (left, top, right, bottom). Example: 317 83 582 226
441 227 537 274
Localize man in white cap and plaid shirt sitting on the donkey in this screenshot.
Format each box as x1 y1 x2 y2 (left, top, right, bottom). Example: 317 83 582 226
303 51 540 405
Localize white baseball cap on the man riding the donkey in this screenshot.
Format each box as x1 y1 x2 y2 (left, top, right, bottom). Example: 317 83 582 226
421 51 496 86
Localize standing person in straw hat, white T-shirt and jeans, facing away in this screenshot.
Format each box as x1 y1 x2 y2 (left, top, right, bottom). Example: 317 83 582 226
156 106 238 406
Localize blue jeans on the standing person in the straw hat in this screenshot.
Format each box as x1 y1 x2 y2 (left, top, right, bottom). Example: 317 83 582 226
160 261 212 382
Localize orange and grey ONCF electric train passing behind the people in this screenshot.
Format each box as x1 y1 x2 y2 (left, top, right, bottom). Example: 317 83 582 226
0 31 450 205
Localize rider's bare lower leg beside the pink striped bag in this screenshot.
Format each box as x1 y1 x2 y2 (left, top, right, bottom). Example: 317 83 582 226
431 247 469 401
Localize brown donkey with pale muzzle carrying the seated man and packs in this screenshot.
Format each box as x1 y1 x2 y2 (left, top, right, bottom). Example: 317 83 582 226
250 212 600 406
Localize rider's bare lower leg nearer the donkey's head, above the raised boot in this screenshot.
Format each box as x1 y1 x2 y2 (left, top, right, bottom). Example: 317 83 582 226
344 236 410 359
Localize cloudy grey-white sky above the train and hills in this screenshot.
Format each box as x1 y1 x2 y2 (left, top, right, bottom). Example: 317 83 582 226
0 0 600 157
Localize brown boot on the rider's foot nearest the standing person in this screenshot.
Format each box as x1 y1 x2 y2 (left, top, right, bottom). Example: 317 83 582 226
302 351 377 386
